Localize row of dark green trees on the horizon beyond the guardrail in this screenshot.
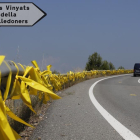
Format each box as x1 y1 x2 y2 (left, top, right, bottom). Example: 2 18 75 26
85 52 124 71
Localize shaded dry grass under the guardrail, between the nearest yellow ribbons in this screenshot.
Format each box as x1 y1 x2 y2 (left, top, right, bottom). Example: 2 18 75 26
6 95 42 133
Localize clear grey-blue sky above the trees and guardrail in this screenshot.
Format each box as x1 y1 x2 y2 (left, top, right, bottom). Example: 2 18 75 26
0 0 140 73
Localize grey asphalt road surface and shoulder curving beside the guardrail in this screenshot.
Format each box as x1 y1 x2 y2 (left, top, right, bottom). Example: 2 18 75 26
29 74 140 140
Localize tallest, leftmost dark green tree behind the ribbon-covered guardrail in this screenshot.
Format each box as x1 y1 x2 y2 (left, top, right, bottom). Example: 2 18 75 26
85 52 102 71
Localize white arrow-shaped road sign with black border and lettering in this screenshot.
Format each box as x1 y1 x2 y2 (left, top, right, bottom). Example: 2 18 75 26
0 2 47 26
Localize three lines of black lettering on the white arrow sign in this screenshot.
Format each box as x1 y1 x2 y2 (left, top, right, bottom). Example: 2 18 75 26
0 5 30 23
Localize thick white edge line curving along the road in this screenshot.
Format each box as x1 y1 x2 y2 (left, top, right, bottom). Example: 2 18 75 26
89 74 140 140
